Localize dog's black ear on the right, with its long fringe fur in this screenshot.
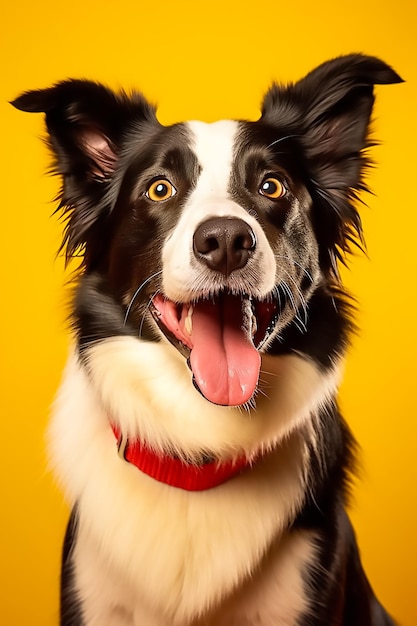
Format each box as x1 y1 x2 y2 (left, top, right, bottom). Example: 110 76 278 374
261 54 402 275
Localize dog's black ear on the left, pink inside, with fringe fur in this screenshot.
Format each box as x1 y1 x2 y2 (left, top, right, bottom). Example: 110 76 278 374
11 80 159 261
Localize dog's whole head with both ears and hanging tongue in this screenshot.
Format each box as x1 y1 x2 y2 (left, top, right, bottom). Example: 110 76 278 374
14 55 401 405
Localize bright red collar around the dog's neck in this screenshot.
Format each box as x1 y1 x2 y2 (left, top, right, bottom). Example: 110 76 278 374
112 426 252 491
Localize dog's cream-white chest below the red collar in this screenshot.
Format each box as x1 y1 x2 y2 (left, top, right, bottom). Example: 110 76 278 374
52 352 322 626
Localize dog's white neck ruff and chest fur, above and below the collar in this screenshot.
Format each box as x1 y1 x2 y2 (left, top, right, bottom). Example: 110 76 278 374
50 337 338 626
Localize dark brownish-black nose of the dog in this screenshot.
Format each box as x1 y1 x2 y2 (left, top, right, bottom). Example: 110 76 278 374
193 217 256 276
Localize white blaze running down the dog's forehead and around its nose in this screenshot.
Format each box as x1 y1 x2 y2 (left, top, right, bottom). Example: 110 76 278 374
162 120 276 302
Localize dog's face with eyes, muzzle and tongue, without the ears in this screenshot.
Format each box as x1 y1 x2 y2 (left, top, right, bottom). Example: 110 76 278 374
106 121 320 405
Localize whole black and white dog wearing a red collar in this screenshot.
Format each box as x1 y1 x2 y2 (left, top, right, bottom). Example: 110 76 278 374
13 55 401 626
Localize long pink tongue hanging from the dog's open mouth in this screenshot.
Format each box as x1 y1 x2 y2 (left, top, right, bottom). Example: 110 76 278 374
190 296 261 406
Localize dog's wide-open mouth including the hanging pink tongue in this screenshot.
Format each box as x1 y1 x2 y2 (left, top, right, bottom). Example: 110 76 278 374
151 291 278 406
